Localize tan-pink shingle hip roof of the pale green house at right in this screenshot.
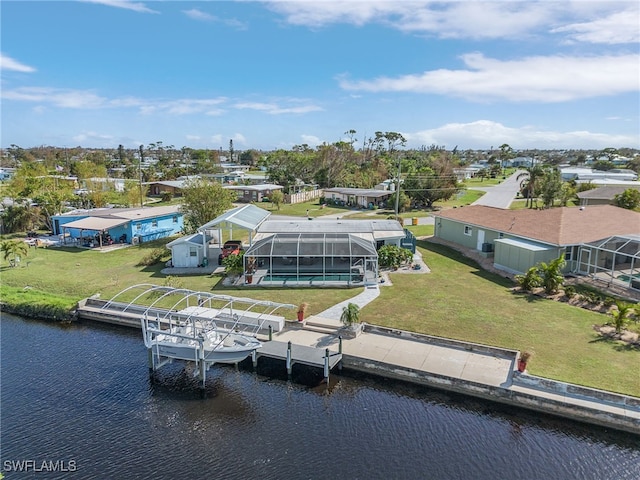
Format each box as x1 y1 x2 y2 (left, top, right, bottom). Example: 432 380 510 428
435 205 640 245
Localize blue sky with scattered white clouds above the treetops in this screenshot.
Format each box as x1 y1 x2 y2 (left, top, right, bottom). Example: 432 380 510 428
0 0 640 151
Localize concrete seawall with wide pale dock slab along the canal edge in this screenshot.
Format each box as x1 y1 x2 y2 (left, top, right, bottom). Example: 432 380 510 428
78 300 640 435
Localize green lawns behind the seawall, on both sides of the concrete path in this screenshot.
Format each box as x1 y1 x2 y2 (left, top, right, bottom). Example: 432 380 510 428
0 225 640 396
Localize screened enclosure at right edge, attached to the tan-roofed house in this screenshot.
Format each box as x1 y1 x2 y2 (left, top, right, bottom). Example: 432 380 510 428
577 235 640 290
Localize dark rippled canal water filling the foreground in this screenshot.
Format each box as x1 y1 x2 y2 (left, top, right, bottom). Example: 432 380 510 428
0 314 640 480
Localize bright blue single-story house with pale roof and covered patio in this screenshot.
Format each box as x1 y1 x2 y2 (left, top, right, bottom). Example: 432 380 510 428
52 205 184 247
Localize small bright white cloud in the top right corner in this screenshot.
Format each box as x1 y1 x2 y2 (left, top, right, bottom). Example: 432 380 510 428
551 8 640 44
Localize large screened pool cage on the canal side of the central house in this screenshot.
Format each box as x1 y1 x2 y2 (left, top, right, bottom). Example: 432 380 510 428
244 232 378 286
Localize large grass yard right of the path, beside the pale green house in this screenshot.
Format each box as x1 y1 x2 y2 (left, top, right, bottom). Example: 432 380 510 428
362 242 640 396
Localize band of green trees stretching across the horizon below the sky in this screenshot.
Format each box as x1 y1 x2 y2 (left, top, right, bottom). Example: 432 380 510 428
0 130 640 232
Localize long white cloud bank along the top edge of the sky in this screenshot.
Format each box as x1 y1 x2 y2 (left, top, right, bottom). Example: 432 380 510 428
268 0 639 43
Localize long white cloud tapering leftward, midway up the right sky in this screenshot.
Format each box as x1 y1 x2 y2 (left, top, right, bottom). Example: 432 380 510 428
340 53 640 102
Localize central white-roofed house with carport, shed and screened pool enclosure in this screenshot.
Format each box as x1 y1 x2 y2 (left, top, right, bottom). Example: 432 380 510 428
167 205 407 286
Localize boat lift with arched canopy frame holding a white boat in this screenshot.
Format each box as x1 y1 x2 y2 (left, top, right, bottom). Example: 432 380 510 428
103 284 296 389
